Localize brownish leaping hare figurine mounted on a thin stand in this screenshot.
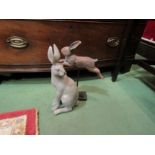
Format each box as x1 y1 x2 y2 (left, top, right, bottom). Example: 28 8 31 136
61 41 103 79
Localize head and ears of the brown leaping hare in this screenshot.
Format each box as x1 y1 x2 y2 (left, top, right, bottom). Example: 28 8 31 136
61 40 82 56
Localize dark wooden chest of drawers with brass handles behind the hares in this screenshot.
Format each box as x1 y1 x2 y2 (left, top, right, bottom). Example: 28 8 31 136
0 20 144 78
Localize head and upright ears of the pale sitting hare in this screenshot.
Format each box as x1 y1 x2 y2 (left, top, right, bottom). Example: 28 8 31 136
47 44 66 77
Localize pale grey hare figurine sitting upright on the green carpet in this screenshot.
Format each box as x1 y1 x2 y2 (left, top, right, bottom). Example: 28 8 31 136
48 44 78 115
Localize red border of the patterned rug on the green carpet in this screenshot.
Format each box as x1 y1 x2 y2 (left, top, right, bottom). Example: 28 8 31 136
0 109 38 135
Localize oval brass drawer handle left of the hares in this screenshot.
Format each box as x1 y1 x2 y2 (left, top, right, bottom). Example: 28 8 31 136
6 36 28 48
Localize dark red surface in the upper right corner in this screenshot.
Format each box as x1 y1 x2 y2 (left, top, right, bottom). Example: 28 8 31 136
143 20 155 41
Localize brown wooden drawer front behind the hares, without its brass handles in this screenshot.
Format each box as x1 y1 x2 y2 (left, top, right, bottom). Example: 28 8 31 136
0 20 126 65
